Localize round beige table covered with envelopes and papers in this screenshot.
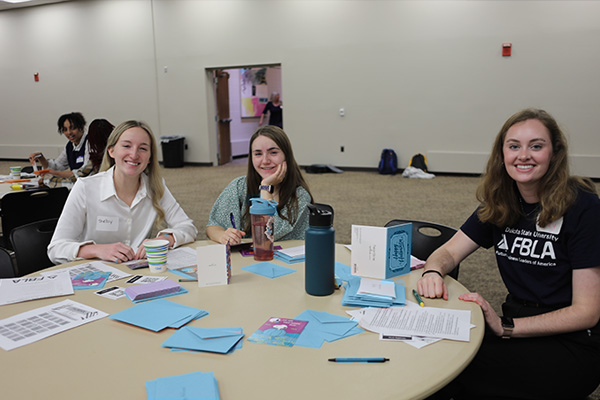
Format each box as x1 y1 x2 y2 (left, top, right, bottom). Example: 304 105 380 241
0 241 484 400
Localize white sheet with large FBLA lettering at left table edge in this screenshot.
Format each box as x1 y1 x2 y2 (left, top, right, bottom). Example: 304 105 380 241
0 273 73 305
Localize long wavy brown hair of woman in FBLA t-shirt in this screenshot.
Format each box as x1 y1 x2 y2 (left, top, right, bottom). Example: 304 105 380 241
477 108 596 227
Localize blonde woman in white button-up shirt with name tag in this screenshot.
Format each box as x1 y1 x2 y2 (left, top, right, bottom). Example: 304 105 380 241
48 121 198 264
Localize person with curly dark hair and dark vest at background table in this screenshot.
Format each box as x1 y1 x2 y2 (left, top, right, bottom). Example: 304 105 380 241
29 112 89 182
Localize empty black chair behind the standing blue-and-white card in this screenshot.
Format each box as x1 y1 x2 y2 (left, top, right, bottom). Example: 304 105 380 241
385 219 459 279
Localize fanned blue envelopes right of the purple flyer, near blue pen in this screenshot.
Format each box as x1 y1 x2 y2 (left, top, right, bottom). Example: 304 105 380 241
294 310 364 349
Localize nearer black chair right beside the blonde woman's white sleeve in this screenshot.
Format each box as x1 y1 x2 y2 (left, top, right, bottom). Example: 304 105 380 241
10 218 58 276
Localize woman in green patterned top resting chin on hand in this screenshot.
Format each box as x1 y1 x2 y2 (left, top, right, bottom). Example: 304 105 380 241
206 125 312 244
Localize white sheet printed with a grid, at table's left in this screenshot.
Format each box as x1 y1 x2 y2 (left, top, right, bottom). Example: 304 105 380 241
0 300 108 350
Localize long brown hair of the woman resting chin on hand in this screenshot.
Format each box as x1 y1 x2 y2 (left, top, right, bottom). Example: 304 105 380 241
242 125 313 232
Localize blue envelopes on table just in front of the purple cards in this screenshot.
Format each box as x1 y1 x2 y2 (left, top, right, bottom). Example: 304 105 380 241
109 299 208 332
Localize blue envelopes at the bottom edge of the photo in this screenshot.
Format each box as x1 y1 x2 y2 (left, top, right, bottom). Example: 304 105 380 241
146 371 221 399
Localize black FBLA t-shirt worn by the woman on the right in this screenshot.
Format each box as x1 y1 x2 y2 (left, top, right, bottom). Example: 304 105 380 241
461 190 600 306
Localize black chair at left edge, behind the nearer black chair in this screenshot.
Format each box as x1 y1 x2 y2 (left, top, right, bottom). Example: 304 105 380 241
0 187 69 250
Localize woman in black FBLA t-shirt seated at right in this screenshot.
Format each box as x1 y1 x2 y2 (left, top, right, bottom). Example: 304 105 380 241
417 109 600 400
